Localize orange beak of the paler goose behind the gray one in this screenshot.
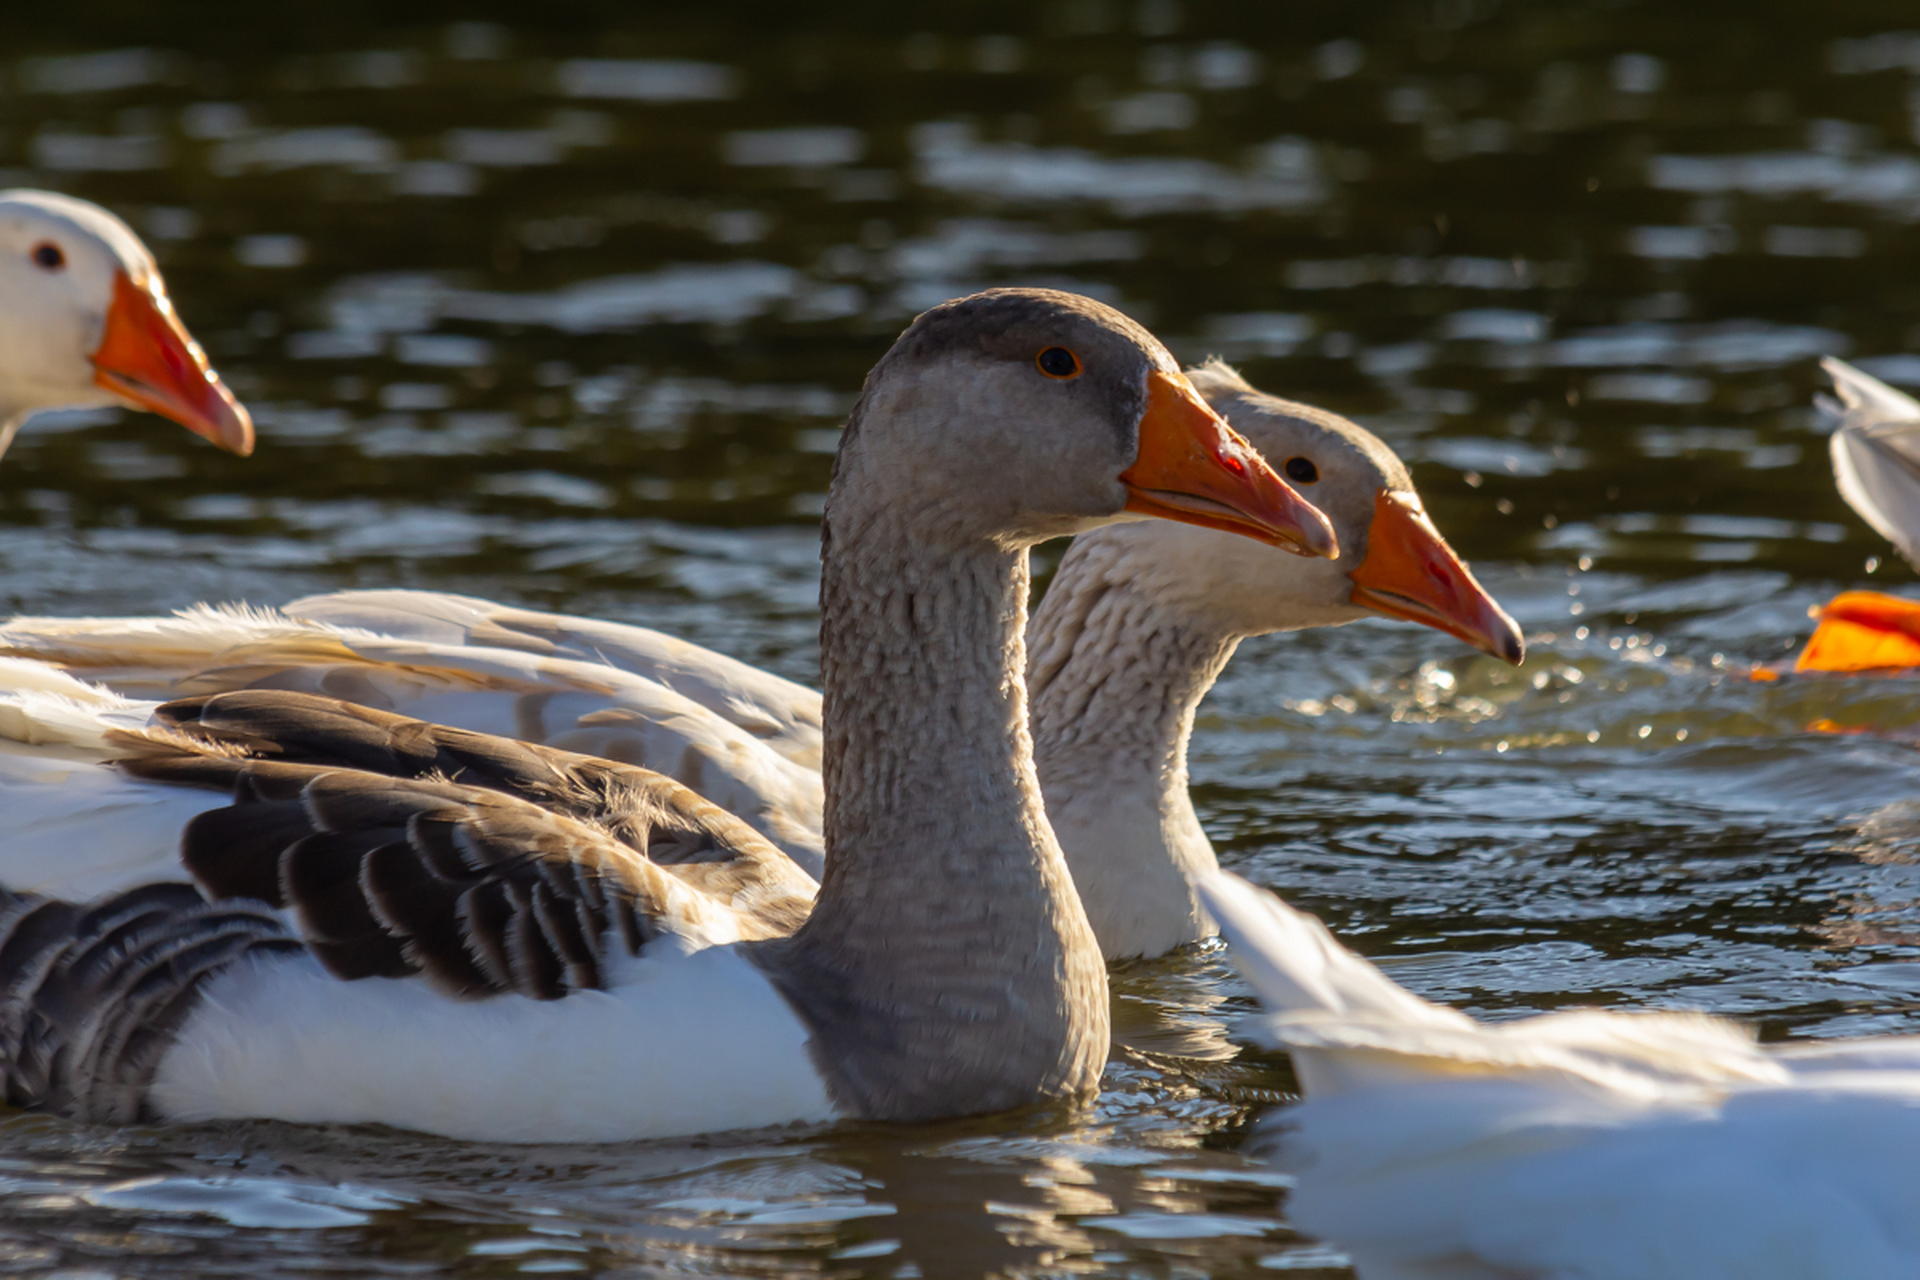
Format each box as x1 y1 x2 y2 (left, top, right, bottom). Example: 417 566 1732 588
1352 489 1526 666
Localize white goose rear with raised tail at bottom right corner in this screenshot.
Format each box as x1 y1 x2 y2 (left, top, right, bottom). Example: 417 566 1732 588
1196 871 1920 1280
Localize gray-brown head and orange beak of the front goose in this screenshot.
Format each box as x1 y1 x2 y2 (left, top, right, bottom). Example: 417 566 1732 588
828 290 1338 558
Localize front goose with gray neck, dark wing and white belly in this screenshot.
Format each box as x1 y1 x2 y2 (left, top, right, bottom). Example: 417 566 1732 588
0 290 1338 1142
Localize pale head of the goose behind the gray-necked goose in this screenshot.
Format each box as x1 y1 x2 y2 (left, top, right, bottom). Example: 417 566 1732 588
1102 361 1526 664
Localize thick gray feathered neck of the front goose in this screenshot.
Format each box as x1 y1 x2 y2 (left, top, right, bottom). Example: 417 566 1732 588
764 453 1108 1119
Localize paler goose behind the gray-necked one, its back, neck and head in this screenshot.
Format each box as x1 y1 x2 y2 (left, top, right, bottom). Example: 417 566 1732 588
0 361 1524 960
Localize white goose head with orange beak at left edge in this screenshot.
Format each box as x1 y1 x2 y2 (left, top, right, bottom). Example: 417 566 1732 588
0 190 253 462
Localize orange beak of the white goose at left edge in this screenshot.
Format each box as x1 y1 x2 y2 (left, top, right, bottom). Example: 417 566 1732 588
94 271 253 457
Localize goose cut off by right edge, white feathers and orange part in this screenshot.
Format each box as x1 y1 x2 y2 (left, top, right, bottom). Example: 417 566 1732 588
1757 357 1920 677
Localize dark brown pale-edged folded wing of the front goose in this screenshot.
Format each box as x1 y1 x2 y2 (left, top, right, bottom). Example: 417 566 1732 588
110 691 812 1000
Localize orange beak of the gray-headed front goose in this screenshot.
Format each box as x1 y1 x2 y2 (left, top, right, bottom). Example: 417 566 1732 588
1119 370 1340 560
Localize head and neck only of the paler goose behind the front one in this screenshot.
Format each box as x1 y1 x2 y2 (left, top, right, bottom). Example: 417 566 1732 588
1027 361 1526 960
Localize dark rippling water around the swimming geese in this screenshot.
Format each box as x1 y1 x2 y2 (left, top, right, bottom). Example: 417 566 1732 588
0 0 1920 1276
